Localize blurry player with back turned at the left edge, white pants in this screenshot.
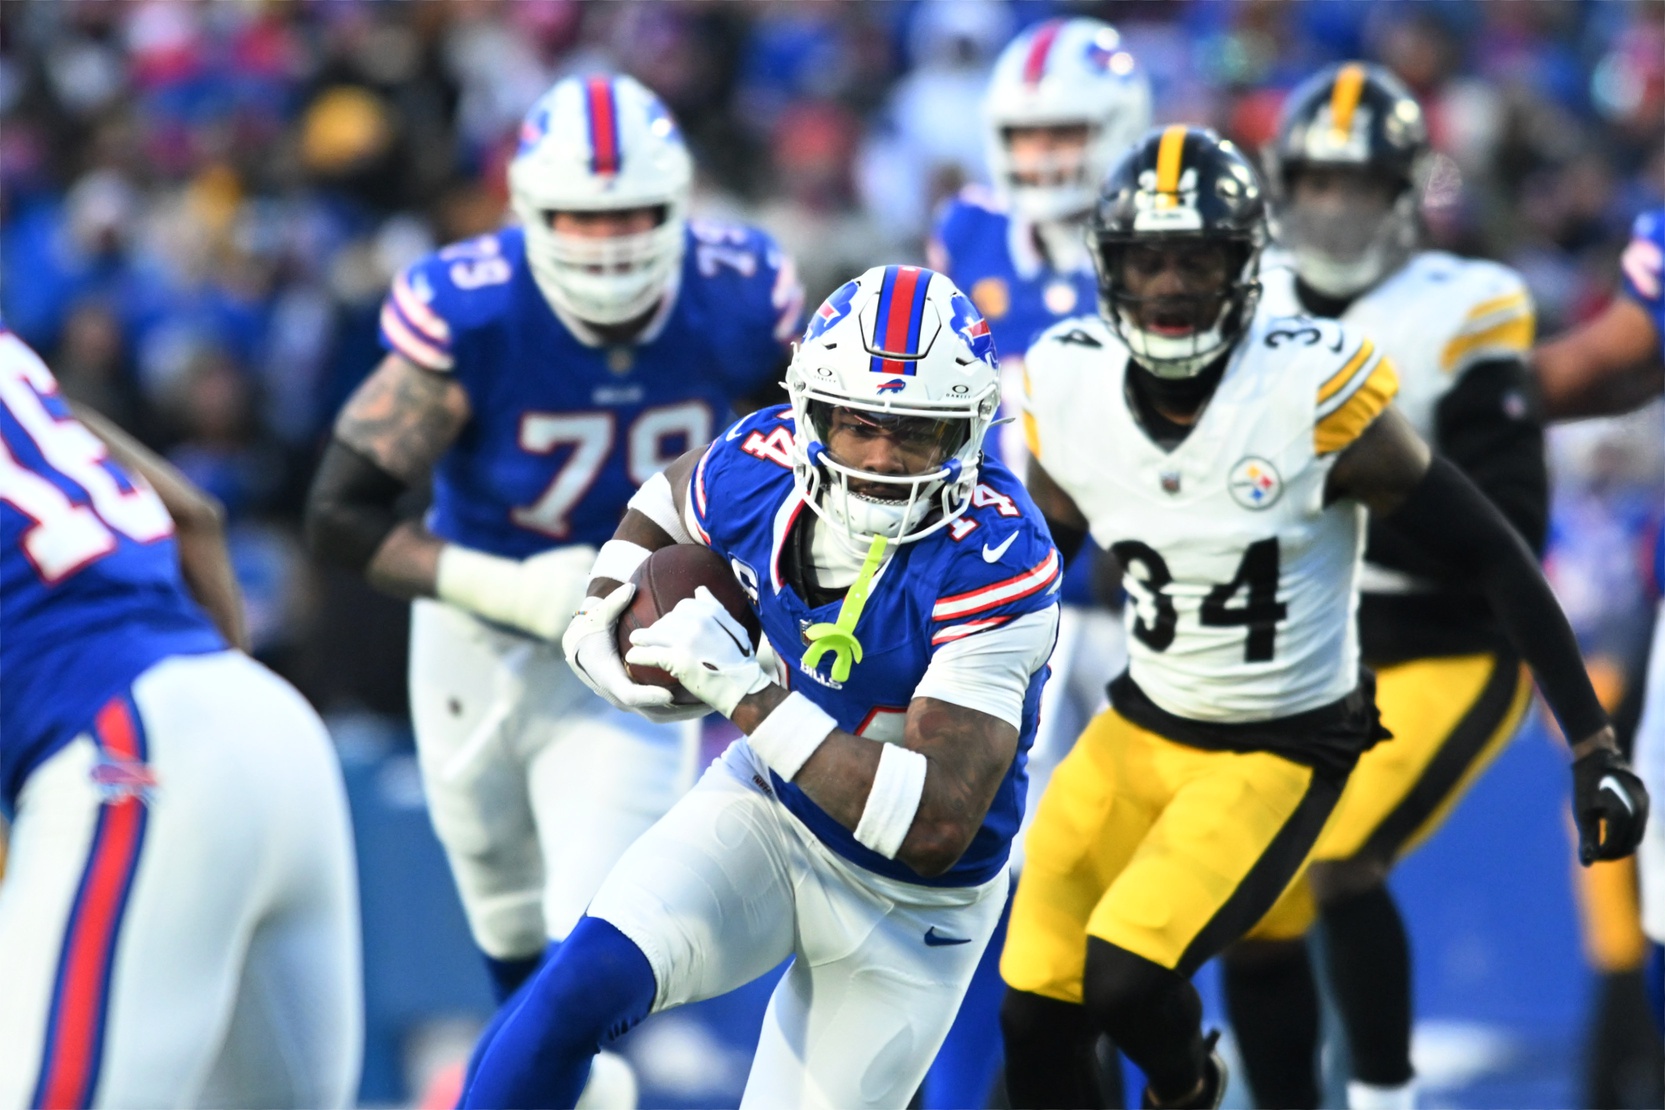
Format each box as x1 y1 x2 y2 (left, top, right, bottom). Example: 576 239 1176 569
0 328 363 1107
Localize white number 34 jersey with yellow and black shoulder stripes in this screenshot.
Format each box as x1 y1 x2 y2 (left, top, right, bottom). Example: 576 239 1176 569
1024 311 1397 722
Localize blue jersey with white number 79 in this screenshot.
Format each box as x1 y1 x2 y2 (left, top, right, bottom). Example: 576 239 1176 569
381 221 803 559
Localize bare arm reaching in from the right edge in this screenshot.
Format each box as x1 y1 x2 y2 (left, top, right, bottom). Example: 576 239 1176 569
1532 296 1665 419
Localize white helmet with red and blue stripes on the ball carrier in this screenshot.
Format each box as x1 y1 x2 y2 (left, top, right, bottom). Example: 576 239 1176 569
786 266 999 551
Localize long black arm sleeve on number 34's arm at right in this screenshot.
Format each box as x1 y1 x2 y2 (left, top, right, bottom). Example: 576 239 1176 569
1389 456 1607 744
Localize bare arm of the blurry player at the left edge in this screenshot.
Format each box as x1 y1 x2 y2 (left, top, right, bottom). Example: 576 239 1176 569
70 401 248 651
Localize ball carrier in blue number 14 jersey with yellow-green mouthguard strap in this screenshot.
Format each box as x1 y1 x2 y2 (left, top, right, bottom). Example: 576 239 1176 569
465 266 1061 1107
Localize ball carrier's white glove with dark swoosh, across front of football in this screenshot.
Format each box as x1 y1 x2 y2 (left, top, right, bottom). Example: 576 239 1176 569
624 586 769 717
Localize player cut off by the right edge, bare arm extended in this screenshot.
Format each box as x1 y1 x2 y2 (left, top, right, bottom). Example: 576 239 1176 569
1532 208 1665 998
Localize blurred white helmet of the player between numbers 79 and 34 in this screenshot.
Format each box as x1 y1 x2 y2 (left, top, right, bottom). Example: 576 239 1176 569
982 18 1151 223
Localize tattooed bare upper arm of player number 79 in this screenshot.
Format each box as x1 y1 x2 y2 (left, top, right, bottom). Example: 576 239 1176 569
335 359 468 483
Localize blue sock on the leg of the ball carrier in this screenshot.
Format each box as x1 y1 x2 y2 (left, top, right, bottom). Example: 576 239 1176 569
463 917 658 1107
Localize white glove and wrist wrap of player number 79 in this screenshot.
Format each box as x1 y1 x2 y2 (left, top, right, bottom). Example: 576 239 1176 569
435 544 596 641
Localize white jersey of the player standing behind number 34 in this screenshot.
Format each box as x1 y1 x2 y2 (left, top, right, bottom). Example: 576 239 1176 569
1260 251 1537 592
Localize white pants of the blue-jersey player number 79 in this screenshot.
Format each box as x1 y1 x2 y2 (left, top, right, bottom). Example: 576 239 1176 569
410 601 699 960
